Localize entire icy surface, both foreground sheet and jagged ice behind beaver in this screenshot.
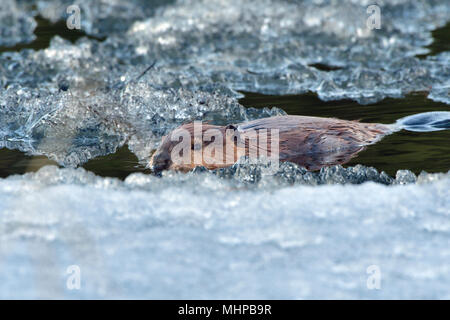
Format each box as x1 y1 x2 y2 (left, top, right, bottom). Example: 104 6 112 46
0 0 450 299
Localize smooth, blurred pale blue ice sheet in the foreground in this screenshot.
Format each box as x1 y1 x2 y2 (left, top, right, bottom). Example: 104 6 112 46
0 166 450 299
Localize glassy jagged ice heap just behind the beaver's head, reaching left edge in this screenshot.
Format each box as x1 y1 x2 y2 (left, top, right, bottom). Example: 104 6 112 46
0 33 284 166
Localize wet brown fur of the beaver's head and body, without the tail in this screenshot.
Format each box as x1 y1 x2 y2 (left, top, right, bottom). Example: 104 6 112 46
150 116 391 171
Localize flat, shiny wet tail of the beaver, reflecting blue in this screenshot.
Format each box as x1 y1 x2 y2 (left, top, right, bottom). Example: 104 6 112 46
395 111 450 132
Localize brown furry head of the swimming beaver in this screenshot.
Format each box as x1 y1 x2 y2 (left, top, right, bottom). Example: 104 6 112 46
149 122 240 173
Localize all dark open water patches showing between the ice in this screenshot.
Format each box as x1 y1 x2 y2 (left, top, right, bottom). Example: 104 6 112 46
0 17 450 179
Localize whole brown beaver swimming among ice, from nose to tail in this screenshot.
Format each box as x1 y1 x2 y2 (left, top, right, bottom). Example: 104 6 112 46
149 112 450 173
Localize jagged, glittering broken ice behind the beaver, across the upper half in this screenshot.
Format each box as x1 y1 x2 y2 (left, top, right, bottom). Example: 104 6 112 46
0 0 450 166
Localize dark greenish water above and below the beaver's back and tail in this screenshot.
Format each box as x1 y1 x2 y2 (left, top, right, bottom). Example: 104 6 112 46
240 92 450 175
